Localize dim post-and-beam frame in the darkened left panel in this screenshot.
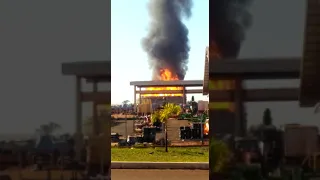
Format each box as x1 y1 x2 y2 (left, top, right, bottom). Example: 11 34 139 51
62 61 111 162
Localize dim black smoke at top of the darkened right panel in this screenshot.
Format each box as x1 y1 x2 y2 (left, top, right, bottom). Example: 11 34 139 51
210 0 252 58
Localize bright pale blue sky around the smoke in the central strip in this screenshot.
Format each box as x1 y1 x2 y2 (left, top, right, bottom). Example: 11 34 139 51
111 0 209 104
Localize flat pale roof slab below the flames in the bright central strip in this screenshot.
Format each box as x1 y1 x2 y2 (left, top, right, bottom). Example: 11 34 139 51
130 80 203 87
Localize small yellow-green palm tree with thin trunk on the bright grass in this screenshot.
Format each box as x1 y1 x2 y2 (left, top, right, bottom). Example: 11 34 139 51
153 103 181 152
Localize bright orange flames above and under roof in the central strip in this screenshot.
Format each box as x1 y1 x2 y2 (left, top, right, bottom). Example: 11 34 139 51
141 68 183 97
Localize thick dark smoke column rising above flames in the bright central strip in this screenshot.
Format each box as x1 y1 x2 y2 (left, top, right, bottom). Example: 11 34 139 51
142 0 192 80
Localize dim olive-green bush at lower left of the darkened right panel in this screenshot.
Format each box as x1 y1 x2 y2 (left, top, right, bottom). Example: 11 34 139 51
210 139 231 173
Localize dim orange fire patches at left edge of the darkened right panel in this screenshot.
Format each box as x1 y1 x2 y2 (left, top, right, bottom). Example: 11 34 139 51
209 42 234 111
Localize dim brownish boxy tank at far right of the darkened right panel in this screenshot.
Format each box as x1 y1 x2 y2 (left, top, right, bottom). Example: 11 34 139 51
284 125 319 157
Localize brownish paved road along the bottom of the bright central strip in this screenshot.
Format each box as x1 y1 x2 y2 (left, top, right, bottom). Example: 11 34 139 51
111 169 209 180
